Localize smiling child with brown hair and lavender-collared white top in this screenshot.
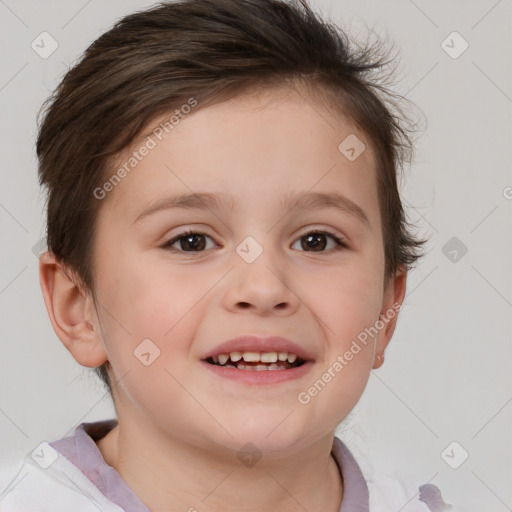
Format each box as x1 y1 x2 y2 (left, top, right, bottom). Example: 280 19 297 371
0 0 456 512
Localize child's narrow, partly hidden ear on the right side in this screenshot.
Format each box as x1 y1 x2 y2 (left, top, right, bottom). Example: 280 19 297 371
372 268 407 370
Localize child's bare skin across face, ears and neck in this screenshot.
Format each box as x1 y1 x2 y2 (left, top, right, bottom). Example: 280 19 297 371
40 89 406 512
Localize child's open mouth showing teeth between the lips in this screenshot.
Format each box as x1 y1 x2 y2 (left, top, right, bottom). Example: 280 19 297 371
205 352 306 372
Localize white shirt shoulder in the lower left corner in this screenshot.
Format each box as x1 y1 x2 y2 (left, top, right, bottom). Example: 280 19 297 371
0 442 122 512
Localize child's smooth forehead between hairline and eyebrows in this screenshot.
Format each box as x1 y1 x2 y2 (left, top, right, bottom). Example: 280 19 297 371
103 89 378 230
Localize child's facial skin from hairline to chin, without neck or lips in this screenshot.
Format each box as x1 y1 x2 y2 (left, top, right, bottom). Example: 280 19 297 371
87 86 404 451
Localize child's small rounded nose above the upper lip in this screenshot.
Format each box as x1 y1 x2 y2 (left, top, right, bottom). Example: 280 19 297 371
224 251 300 316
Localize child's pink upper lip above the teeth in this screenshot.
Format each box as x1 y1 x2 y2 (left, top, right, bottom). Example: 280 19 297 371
201 334 314 361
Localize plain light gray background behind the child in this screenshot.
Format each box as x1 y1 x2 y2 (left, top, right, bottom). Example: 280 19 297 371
0 0 512 512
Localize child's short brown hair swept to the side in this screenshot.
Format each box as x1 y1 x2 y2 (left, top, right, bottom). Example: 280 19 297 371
37 0 427 392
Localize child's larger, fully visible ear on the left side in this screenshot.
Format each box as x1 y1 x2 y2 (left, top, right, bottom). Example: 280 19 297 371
39 251 108 368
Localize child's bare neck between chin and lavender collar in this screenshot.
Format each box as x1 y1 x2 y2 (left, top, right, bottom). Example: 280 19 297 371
97 421 343 512
